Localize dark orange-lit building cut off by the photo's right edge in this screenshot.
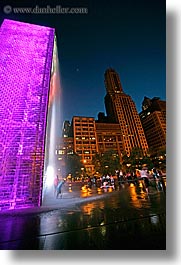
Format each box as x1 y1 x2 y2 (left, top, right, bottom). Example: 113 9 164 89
139 97 166 150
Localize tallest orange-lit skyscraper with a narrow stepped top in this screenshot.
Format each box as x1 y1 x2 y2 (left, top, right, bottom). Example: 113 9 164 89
105 69 148 155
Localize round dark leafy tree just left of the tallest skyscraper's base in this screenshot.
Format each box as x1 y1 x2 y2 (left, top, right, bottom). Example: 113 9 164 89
92 150 120 175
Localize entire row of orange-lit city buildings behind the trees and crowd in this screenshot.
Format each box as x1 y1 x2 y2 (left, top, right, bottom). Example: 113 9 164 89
56 68 166 175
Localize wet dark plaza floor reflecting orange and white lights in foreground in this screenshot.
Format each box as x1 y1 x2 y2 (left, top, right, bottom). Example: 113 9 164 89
0 180 166 250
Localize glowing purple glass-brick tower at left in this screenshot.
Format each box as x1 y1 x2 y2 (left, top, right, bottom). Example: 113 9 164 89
0 20 55 211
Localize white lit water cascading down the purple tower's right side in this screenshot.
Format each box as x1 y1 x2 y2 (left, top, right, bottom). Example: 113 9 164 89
42 37 61 205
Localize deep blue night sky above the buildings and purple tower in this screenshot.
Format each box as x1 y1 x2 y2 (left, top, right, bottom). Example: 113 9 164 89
0 0 166 124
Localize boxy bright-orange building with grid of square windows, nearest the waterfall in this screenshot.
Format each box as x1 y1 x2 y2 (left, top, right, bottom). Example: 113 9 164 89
72 117 98 174
